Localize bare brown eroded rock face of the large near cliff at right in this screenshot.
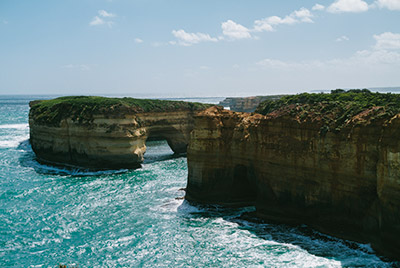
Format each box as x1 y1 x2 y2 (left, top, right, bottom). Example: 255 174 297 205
186 106 400 259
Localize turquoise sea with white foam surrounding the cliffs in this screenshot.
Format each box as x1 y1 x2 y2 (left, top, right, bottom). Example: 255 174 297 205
0 96 396 267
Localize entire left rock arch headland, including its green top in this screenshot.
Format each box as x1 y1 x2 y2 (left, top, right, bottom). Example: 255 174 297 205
29 96 210 169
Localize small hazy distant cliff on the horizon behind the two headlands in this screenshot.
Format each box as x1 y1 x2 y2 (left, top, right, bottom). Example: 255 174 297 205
219 95 283 113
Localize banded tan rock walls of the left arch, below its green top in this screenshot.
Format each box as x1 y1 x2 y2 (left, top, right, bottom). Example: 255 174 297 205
29 107 200 169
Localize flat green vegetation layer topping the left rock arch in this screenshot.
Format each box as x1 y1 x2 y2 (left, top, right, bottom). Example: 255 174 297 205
30 96 211 125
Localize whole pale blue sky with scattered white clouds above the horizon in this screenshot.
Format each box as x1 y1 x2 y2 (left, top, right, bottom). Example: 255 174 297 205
0 0 400 97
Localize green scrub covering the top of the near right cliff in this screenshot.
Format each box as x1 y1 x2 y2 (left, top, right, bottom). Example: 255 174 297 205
256 89 400 131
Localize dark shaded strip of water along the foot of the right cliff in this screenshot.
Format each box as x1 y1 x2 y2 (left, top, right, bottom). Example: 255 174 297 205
178 200 400 267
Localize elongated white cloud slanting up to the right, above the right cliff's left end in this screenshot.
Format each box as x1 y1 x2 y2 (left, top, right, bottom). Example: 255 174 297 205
254 7 313 32
